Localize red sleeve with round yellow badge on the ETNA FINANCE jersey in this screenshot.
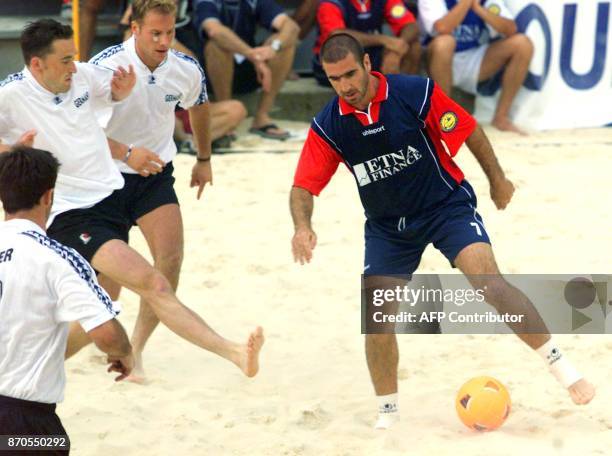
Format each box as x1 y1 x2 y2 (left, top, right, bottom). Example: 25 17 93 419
425 84 476 157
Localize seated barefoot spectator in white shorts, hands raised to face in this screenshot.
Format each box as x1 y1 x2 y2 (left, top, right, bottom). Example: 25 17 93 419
419 0 533 134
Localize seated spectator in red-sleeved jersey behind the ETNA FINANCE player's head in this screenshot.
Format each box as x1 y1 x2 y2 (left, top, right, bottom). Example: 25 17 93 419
313 0 421 85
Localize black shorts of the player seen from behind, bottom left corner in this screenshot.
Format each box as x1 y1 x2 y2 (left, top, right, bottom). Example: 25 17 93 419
0 396 69 456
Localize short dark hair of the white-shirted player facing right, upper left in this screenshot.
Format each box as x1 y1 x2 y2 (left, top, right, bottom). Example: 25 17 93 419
21 19 73 65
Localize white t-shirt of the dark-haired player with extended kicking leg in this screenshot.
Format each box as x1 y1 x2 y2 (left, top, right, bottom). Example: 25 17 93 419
0 63 123 224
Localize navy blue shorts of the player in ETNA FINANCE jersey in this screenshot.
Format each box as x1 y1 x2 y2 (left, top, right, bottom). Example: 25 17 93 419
363 181 491 275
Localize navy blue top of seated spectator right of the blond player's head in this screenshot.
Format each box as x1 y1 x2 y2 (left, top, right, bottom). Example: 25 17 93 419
193 0 284 46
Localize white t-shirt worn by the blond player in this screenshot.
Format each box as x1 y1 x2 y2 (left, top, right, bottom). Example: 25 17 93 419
90 37 208 174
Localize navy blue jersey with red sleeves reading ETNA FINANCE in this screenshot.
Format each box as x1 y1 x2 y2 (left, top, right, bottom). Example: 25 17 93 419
294 72 476 219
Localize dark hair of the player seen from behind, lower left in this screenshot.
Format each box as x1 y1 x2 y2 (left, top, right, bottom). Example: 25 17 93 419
0 146 60 214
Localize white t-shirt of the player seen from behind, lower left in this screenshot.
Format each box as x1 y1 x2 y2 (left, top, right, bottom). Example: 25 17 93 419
0 219 119 404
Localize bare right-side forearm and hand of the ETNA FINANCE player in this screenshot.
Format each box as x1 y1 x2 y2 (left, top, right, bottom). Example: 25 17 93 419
465 125 514 209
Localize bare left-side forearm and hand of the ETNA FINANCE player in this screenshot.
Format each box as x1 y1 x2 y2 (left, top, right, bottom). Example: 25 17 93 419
289 187 317 264
